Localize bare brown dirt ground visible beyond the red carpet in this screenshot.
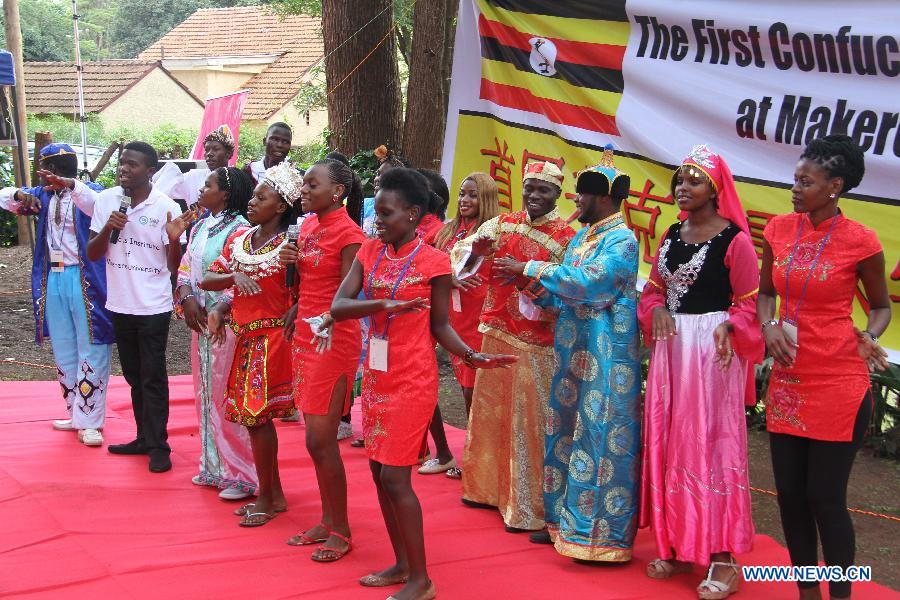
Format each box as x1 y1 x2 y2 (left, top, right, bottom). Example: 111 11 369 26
0 248 900 590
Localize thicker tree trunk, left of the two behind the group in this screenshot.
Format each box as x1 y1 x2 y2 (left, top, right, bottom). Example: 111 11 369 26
322 0 400 156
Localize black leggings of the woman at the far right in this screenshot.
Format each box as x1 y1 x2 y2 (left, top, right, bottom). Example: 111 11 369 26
769 392 873 598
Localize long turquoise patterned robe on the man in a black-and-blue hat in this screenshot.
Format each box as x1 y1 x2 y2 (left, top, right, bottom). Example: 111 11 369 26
525 213 641 562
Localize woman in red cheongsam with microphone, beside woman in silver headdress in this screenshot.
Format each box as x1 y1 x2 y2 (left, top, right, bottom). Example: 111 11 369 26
281 159 366 562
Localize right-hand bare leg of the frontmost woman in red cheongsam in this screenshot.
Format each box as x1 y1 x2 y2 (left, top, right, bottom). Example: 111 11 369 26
380 465 431 600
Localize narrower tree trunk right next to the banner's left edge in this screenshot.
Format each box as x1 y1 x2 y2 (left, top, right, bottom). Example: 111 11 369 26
403 0 459 169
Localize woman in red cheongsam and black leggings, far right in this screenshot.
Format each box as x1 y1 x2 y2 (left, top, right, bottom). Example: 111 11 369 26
757 135 891 598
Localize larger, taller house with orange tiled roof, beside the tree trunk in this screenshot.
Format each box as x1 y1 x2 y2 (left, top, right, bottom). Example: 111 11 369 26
144 6 328 143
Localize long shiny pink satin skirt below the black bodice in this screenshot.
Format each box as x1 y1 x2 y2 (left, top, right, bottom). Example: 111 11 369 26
640 312 754 565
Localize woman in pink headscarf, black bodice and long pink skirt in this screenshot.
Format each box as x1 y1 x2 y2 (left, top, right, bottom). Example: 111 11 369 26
638 146 763 600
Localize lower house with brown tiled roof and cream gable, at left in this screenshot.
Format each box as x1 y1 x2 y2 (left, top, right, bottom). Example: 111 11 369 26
24 59 203 128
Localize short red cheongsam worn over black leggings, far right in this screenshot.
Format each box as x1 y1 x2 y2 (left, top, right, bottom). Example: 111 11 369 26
763 213 882 442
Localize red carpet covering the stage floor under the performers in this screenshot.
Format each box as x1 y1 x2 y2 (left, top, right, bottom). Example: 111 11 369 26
0 377 900 600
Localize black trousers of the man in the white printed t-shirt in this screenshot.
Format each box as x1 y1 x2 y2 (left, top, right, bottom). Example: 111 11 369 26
110 312 172 454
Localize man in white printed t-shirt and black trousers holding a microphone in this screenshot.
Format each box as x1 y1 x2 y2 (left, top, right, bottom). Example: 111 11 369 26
59 142 181 473
